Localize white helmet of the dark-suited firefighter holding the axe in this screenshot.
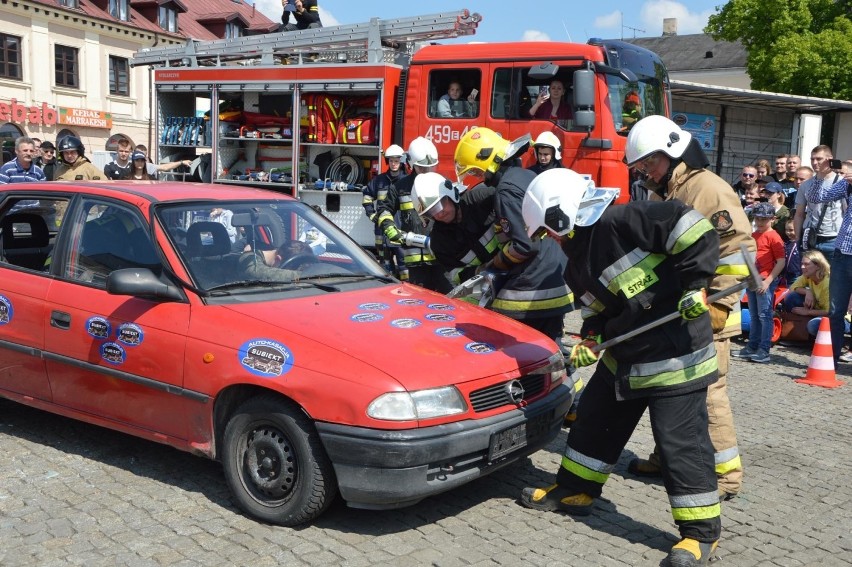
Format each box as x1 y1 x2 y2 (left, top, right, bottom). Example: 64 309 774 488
521 168 619 236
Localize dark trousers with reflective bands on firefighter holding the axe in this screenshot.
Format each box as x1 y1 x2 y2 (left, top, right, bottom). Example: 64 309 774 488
556 364 722 542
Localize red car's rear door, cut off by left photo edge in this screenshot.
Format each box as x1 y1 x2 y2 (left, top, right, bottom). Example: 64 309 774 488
0 197 67 402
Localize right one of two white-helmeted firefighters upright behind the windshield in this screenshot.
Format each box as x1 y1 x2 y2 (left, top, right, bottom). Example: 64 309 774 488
375 136 453 293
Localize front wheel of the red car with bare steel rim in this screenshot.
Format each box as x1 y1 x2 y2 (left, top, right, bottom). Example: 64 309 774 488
222 395 337 526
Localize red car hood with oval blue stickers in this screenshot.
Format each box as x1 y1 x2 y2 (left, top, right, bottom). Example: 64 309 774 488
220 284 557 390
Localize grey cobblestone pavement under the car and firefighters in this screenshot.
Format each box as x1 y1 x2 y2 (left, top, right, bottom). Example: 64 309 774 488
0 314 852 567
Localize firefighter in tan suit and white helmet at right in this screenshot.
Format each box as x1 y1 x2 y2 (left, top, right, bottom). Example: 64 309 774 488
625 116 755 500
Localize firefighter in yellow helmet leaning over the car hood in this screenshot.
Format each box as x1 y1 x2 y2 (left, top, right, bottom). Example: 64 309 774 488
455 128 574 341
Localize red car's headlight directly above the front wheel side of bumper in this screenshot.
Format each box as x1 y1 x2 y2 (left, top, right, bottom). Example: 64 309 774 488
367 386 467 421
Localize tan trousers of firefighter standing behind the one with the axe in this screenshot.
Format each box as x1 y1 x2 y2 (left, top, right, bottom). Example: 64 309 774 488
648 339 743 494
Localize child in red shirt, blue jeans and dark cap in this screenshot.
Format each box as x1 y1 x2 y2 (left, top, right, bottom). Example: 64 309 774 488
733 203 784 362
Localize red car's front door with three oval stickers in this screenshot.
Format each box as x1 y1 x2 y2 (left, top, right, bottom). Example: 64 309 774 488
45 197 193 439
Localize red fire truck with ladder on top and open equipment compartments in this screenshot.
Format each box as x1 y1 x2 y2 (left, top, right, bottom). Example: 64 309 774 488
131 6 671 247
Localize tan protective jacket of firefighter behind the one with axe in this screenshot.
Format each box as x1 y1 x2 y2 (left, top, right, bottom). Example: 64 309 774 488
647 163 757 340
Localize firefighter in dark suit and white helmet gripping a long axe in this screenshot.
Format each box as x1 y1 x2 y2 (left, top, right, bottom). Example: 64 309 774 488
520 169 721 566
